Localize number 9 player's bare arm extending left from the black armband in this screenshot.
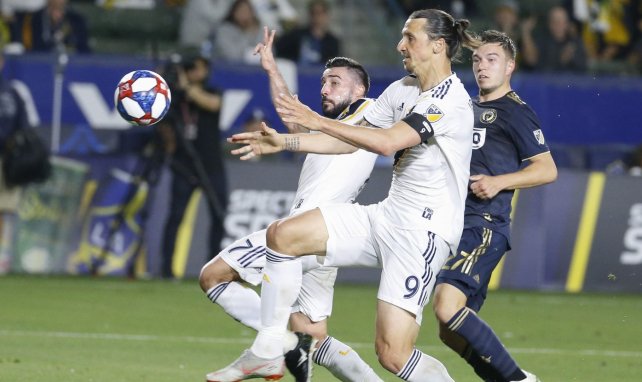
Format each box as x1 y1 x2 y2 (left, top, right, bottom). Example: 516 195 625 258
276 94 421 156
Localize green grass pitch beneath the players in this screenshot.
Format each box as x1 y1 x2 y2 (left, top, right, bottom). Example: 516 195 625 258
0 275 642 382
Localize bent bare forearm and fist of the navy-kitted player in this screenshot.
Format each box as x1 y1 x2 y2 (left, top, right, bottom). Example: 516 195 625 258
470 152 557 199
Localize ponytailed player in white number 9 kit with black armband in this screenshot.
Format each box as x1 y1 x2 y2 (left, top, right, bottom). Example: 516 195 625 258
216 9 477 382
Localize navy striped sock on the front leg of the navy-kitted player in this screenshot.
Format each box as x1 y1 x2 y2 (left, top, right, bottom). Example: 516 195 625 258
447 307 526 381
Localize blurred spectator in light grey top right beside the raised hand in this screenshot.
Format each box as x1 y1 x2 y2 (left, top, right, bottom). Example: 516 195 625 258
213 0 263 62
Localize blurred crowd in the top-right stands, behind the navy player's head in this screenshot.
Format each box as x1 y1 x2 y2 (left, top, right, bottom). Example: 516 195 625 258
397 0 642 74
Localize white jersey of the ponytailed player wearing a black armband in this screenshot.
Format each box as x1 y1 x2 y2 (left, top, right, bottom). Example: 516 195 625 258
365 73 474 253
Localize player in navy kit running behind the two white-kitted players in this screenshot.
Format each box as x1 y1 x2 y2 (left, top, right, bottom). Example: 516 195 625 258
433 30 557 381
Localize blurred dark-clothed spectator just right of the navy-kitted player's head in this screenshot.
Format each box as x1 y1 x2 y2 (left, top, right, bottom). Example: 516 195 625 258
522 6 587 72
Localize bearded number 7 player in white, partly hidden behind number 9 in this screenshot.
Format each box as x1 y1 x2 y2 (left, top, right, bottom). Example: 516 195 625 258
199 28 381 382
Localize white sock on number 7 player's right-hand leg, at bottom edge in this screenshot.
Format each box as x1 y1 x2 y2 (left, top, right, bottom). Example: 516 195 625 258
313 336 383 382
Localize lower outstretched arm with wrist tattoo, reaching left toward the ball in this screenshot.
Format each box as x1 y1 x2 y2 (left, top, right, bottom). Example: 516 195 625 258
227 122 357 160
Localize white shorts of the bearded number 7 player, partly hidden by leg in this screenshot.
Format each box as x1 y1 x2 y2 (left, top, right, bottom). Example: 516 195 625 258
219 230 337 322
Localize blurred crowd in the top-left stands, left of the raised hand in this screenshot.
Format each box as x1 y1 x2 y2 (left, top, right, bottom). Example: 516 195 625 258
0 0 341 64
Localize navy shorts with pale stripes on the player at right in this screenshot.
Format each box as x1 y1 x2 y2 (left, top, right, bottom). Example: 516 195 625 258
437 227 508 312
